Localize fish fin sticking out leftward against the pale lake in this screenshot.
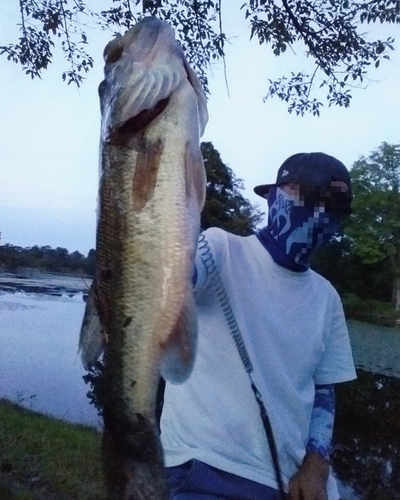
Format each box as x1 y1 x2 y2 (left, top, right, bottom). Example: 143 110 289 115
79 281 105 370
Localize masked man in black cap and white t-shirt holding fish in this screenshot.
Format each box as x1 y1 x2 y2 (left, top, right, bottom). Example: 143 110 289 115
161 153 355 500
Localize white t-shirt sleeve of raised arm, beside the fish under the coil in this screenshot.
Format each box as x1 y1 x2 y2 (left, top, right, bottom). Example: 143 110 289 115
194 228 228 295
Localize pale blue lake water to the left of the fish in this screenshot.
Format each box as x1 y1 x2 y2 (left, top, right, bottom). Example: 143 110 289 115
0 274 99 426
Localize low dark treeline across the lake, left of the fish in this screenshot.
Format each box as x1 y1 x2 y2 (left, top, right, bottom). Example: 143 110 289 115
0 244 96 276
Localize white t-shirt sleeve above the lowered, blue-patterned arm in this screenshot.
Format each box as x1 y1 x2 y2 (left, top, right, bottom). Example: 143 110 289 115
314 291 357 384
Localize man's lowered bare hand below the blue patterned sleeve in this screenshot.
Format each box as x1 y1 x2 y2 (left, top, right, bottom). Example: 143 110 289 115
289 453 329 500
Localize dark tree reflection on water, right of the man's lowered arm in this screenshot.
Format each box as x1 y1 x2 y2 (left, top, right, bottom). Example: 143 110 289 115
332 370 400 500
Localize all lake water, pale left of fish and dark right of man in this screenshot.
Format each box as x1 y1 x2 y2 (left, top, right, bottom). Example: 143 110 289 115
0 274 400 500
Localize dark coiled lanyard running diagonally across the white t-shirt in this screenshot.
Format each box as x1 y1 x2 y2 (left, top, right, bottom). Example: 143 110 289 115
199 234 286 500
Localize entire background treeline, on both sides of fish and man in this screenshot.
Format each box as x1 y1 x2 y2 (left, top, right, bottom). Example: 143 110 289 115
0 142 400 324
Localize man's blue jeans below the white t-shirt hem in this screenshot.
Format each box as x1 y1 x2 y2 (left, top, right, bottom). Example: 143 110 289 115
167 460 284 500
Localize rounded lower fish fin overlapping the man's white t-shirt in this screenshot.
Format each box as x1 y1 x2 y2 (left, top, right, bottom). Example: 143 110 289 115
160 289 197 384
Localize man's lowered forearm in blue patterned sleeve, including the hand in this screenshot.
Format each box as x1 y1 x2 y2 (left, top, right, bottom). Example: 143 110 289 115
289 384 335 500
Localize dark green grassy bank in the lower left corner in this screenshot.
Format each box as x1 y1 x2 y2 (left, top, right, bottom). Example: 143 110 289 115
0 399 105 500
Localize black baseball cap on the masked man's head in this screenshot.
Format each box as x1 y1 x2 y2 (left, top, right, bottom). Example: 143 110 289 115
254 153 351 200
